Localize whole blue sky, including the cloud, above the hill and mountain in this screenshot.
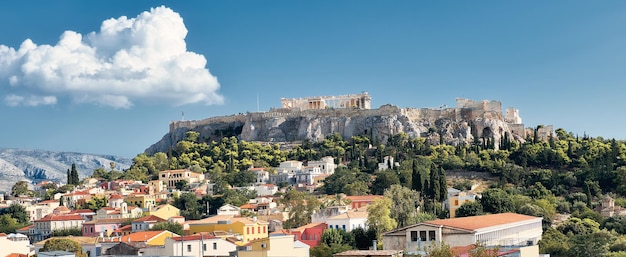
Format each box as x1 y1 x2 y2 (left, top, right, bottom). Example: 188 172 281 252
0 0 626 157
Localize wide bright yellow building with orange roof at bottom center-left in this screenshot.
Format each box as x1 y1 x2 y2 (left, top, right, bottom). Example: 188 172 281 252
189 215 269 243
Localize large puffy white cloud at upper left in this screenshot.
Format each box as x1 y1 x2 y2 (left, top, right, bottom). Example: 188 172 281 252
0 6 223 108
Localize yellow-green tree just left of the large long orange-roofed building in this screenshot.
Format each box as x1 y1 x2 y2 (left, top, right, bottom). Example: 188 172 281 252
367 197 398 239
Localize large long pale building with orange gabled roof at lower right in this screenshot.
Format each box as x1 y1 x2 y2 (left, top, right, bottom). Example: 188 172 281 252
383 213 543 253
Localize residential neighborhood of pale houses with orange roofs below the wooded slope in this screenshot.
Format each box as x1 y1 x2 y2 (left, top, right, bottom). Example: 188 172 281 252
0 153 542 257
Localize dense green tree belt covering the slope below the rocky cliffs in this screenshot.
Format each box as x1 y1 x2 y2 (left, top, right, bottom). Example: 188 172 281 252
107 129 626 256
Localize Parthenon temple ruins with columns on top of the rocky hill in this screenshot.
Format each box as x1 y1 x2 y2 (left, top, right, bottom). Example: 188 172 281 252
280 92 372 110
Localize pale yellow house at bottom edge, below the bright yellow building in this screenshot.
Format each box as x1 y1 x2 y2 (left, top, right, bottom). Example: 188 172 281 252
237 235 310 257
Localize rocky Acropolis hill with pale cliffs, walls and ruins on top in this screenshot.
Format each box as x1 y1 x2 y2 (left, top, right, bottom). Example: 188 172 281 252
146 92 552 154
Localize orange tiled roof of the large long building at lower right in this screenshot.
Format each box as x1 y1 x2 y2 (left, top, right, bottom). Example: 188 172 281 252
424 213 540 231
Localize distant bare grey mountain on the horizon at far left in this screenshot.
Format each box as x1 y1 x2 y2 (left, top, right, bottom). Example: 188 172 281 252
0 148 132 191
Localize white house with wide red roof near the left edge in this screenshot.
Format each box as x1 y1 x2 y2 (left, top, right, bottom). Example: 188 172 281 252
30 214 85 242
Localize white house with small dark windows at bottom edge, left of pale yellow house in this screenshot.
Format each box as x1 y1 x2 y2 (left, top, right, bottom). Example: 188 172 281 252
143 233 237 257
